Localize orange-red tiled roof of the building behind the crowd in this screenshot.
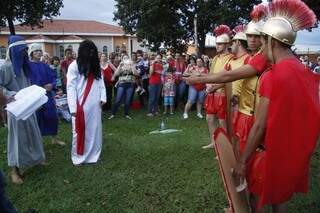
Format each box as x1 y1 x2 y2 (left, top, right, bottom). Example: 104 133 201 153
2 19 124 34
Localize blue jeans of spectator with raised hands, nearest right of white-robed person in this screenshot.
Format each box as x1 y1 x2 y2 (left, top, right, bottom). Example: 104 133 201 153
112 83 134 115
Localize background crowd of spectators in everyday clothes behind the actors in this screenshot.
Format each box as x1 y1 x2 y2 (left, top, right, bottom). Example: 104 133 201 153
19 43 211 121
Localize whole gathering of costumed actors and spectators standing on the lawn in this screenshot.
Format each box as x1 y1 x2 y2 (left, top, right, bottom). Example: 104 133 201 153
0 0 320 212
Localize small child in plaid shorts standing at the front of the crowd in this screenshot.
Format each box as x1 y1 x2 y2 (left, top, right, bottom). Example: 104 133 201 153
162 68 176 115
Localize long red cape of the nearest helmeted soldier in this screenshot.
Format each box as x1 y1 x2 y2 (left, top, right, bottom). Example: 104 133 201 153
254 58 320 207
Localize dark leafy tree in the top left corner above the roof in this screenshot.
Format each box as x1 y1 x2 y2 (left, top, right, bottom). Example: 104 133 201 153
0 0 63 35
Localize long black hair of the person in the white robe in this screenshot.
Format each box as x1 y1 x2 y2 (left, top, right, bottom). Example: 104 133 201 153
77 39 101 80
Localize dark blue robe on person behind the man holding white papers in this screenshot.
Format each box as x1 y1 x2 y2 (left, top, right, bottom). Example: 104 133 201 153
30 62 58 136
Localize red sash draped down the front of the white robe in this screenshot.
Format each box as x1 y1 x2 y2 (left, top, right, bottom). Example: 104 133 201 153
75 73 94 155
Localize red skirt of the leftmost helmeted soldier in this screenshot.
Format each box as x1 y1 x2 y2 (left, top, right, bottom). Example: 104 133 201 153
204 92 227 119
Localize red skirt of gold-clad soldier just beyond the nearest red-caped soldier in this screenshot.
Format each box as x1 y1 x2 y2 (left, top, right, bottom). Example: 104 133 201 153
234 112 254 152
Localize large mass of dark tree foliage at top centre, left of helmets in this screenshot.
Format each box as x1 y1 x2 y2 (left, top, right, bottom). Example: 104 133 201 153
114 0 261 52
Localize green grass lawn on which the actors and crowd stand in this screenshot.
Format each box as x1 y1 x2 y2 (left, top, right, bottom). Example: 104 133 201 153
0 111 320 212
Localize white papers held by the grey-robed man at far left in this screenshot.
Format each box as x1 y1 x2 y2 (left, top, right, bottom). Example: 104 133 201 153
6 85 48 120
